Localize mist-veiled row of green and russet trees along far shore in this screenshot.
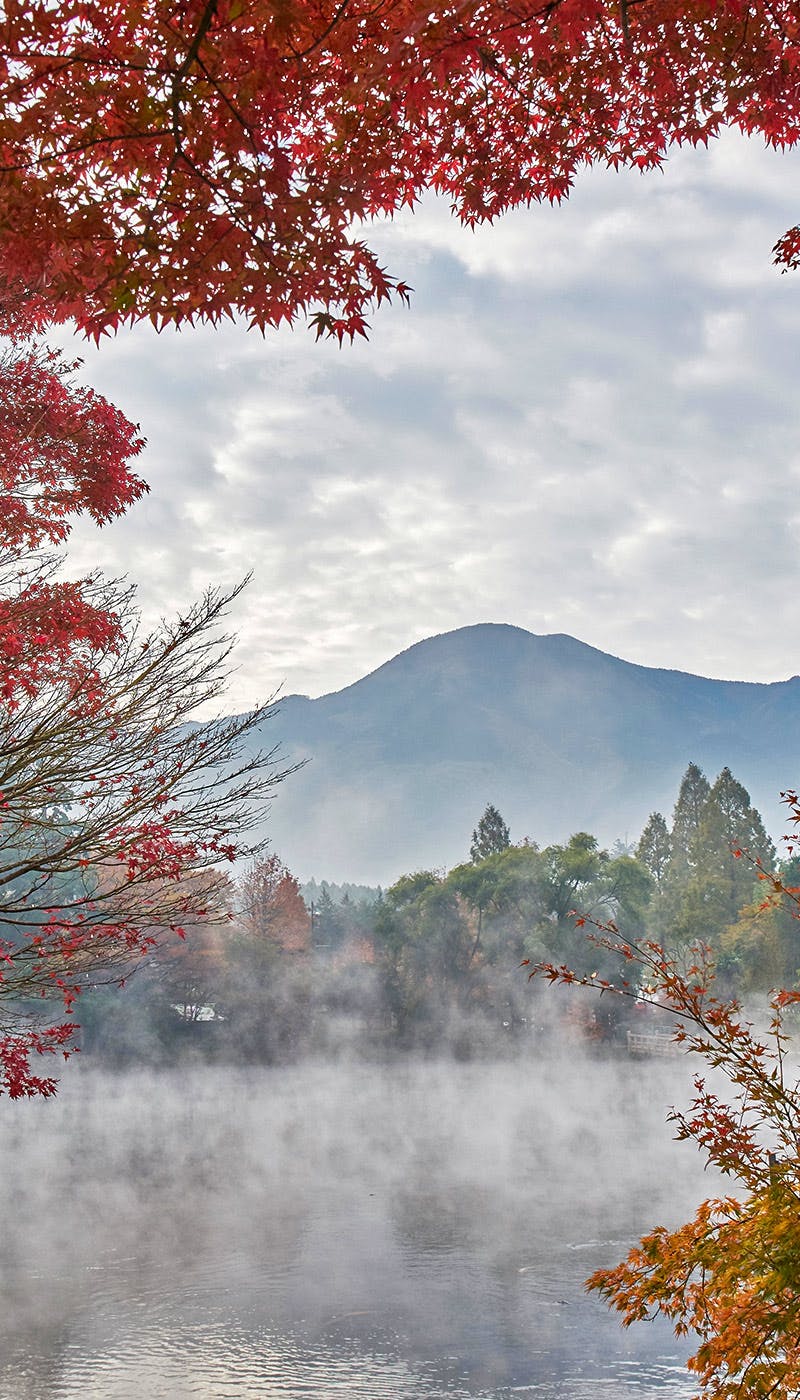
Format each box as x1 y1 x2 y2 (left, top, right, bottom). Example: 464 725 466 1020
67 763 800 1064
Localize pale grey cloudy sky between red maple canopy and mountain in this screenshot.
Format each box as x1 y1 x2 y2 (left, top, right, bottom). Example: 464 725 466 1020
53 136 800 708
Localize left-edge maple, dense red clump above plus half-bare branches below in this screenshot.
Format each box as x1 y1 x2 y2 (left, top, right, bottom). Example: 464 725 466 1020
0 343 282 1096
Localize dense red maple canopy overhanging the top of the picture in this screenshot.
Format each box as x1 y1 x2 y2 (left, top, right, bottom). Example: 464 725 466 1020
0 0 800 340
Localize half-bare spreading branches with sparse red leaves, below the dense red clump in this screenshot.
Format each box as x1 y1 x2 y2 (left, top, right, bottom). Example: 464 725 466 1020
0 568 282 1095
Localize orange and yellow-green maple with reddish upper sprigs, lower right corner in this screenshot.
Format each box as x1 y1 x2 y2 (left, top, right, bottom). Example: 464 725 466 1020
524 792 800 1400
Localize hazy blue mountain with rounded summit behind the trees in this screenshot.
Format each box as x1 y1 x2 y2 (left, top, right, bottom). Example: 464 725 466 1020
245 623 800 885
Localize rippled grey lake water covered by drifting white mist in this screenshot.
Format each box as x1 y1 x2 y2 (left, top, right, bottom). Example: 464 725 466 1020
0 1047 716 1400
